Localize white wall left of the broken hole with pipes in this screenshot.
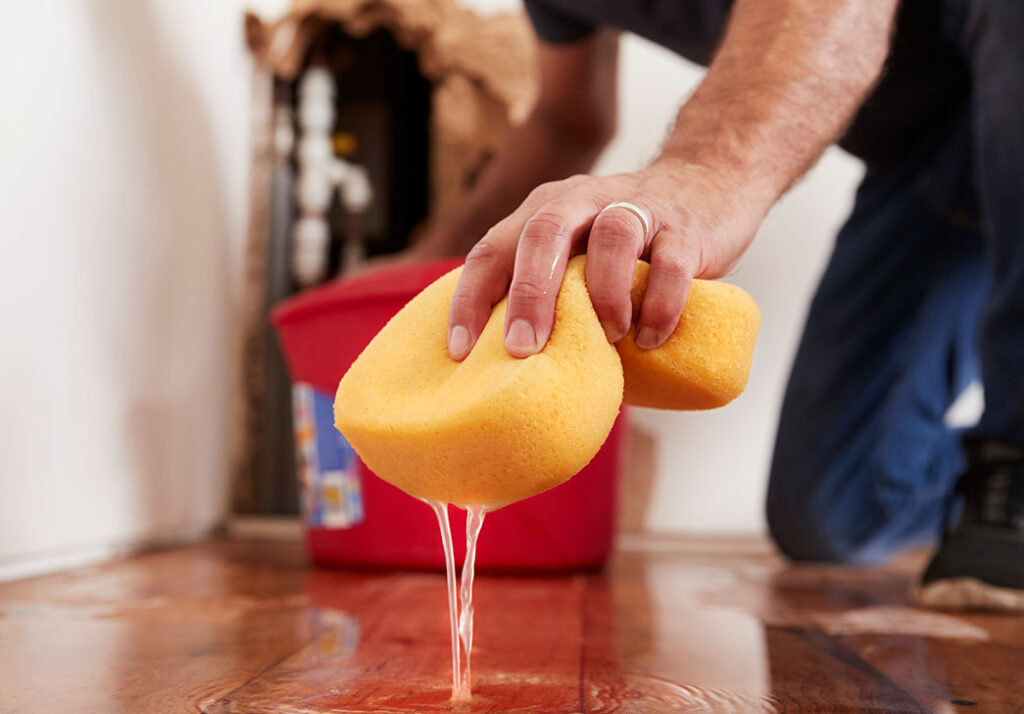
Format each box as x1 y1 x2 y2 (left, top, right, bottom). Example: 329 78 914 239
0 0 250 578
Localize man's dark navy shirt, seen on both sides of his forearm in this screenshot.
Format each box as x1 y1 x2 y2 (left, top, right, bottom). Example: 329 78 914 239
524 0 966 168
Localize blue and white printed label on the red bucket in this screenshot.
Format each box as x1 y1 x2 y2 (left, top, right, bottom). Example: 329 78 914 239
292 383 366 529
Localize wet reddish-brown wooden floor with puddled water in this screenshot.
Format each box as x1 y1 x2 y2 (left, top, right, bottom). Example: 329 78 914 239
0 541 1024 714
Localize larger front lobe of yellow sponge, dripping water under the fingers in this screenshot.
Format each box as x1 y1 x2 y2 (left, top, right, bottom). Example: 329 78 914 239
334 260 623 507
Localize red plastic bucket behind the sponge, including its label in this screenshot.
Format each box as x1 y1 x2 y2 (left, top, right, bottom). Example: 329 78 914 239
271 260 625 571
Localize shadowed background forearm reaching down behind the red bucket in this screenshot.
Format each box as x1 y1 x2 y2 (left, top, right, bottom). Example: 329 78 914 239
435 108 607 254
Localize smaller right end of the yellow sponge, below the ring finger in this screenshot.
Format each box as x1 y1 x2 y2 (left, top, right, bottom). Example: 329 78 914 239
615 261 761 409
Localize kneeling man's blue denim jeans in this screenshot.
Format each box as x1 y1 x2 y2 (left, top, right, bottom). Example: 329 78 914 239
767 0 1024 562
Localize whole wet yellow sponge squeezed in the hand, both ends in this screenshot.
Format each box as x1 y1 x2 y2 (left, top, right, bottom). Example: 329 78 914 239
334 256 760 508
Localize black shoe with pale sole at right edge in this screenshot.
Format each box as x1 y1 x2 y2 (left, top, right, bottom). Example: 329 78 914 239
912 443 1024 612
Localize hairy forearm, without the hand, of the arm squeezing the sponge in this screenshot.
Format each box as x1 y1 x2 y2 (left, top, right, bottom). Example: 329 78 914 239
657 0 897 204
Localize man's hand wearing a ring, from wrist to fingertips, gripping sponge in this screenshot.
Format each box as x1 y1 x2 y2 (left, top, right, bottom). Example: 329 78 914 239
449 161 770 360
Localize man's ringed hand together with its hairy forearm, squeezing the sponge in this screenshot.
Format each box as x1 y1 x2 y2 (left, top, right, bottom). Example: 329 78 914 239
449 0 896 360
